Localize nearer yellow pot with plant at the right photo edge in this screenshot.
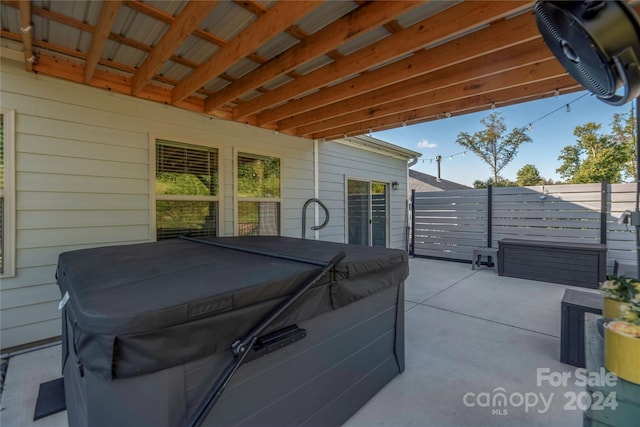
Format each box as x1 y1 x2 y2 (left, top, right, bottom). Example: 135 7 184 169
604 300 640 384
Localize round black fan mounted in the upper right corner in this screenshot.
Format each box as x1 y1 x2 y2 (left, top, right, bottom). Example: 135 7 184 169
535 0 640 105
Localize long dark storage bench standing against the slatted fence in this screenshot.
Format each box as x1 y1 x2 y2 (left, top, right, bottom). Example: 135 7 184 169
498 239 607 289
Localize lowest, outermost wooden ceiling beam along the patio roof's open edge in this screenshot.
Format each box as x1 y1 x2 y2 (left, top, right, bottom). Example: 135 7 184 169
312 74 582 140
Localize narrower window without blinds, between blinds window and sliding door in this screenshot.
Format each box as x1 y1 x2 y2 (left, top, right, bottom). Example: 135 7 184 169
236 152 281 236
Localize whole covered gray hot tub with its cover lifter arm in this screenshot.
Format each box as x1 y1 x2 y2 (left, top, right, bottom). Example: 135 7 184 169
57 237 408 427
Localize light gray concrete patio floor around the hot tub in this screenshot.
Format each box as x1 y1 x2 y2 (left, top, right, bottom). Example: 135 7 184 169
0 258 596 427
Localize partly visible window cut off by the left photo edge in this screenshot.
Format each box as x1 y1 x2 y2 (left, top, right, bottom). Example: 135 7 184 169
0 110 16 277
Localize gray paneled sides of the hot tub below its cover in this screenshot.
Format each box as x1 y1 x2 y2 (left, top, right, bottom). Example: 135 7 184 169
64 282 404 427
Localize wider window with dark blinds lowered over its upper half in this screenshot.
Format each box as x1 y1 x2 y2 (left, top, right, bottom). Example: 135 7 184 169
155 140 219 240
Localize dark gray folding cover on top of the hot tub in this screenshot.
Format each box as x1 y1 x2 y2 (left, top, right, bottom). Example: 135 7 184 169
57 237 409 379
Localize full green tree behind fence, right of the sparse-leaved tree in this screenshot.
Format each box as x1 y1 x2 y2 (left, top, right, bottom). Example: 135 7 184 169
556 117 631 184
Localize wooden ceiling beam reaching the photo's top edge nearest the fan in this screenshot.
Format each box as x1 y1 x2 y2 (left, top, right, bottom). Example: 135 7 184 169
234 1 533 119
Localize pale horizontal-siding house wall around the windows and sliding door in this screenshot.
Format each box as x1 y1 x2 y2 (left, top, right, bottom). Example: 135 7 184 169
0 58 406 349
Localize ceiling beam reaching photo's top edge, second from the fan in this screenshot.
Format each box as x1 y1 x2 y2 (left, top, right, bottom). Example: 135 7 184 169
205 1 423 111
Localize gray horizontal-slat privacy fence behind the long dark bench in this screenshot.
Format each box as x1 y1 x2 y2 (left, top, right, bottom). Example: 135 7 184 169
411 183 636 272
